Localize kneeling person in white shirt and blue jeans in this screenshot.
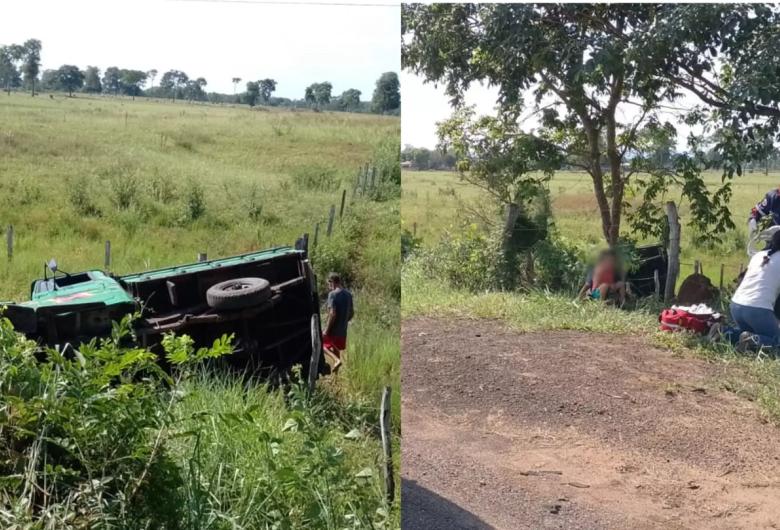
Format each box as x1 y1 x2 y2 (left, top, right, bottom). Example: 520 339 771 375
709 232 780 352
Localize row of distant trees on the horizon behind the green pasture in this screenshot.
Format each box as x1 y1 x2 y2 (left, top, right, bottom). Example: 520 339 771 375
0 39 401 116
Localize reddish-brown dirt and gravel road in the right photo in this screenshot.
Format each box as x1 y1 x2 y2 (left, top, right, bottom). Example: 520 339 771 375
402 319 780 530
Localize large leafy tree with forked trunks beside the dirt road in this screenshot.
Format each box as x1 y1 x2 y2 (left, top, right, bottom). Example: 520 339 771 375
402 4 780 244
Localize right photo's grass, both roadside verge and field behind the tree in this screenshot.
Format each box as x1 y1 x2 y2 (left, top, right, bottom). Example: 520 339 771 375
401 165 780 424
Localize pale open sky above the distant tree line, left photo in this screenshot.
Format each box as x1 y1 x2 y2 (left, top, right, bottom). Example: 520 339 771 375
0 0 401 100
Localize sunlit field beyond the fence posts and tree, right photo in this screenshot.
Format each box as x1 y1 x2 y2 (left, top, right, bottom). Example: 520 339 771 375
401 171 780 284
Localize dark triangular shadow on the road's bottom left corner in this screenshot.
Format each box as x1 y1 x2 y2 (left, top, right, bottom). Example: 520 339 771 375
401 478 495 530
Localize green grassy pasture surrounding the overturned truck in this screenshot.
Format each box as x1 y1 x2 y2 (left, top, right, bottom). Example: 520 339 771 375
0 94 401 528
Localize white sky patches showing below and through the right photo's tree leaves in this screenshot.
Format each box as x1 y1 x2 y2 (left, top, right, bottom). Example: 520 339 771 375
399 70 698 151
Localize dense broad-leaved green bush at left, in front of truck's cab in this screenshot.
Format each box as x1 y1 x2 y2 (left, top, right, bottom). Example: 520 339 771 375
0 317 230 529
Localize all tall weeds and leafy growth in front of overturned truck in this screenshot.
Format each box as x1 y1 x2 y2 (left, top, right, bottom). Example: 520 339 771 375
0 318 390 530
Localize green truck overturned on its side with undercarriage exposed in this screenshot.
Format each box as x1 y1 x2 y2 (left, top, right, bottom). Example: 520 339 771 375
3 247 328 376
